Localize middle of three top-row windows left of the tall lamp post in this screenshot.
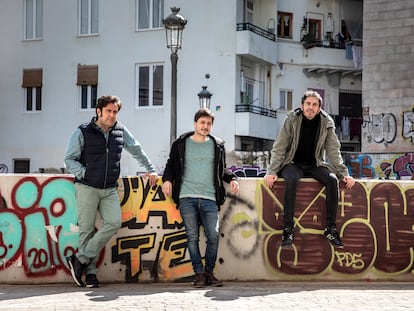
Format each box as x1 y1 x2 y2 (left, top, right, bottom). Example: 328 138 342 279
79 0 99 35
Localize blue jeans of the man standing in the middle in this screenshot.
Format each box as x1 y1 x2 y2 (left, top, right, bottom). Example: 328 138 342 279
179 198 219 273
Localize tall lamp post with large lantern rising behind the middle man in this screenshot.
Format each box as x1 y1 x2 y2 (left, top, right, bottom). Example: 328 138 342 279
162 7 187 144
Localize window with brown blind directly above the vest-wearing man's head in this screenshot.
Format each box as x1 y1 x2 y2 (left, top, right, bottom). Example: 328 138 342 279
76 65 98 110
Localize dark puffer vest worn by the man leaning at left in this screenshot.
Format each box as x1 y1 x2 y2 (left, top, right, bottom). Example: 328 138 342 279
76 119 124 189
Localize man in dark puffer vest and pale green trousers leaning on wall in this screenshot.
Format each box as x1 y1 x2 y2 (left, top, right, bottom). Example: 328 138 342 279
64 96 158 287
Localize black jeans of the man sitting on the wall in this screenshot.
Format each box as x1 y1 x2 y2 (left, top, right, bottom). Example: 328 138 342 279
280 164 339 228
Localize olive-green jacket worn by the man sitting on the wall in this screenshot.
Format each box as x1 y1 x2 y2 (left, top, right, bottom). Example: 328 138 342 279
267 108 349 180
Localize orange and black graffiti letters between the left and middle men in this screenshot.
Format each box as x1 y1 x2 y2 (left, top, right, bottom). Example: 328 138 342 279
112 177 192 282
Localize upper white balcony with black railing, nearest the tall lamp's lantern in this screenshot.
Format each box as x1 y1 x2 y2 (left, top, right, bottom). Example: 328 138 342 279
236 23 277 65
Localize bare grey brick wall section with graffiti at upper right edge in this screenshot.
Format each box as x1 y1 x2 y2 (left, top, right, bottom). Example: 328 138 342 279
362 0 414 152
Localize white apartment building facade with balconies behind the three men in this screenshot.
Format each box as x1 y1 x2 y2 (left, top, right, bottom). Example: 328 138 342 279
0 0 362 175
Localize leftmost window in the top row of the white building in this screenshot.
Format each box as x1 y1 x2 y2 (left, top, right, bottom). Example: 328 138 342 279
24 0 43 40
